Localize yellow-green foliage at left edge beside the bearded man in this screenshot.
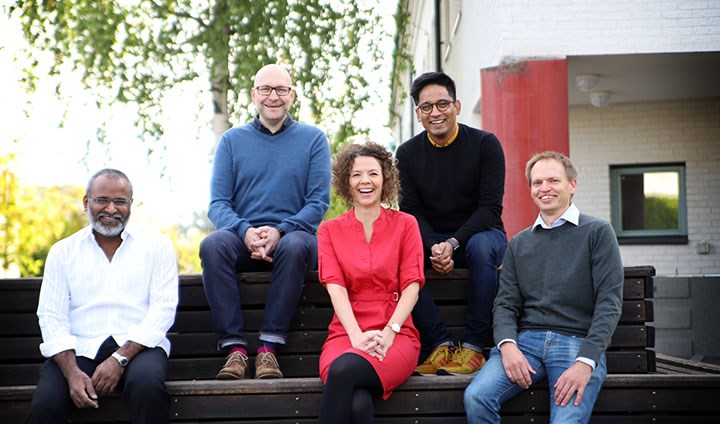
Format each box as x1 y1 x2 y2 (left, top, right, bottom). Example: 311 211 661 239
0 156 87 277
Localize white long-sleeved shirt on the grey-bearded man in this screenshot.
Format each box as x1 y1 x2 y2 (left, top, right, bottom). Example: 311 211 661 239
37 227 178 359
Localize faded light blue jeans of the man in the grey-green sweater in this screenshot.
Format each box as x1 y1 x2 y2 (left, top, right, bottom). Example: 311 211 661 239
464 331 607 424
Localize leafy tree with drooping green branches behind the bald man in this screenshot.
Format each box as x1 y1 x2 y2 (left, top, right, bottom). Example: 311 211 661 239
8 0 382 147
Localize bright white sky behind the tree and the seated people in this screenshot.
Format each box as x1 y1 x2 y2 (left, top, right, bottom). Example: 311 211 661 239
0 2 394 229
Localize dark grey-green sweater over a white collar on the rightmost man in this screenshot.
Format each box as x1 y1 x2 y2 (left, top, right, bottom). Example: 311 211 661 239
493 214 624 362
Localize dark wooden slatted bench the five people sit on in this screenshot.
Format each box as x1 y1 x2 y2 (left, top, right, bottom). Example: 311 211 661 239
0 267 720 423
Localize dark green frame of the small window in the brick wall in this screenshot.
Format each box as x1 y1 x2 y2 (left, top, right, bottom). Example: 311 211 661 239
610 162 688 244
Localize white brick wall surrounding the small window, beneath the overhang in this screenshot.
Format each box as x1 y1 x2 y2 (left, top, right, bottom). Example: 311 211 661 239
570 99 720 276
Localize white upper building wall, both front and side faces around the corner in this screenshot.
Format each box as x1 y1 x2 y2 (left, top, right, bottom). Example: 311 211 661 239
434 0 720 131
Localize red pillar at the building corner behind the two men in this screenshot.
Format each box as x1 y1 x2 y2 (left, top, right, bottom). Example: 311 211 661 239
481 59 570 238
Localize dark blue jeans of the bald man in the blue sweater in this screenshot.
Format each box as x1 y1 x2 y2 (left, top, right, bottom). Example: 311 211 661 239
200 230 317 349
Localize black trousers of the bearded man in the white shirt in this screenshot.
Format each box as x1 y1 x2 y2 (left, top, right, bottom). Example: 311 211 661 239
25 337 170 424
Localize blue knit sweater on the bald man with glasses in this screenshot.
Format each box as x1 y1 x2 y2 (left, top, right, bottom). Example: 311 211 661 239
208 117 330 238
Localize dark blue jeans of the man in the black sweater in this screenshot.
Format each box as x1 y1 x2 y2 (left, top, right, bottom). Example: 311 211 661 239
412 228 507 350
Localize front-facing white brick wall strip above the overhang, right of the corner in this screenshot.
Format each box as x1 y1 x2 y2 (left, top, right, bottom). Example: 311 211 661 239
501 0 720 57
